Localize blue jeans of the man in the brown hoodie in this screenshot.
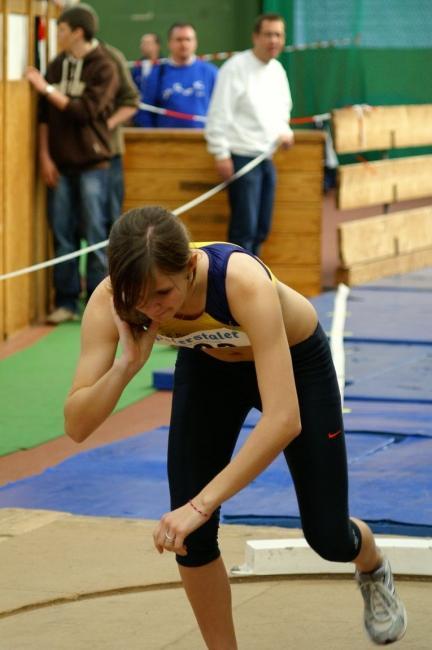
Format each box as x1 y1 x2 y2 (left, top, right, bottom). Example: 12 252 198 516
48 169 109 312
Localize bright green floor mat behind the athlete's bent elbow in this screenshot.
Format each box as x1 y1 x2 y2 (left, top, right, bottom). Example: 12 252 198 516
0 323 176 456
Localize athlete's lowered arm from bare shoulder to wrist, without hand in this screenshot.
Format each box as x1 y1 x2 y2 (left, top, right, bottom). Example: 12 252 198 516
197 254 301 511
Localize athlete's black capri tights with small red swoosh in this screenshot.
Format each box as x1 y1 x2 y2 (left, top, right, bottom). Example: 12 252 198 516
168 325 361 566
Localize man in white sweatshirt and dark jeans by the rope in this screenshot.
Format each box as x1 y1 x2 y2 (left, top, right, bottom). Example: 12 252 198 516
205 14 294 255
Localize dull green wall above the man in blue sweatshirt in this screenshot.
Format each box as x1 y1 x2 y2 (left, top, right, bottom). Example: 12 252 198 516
89 0 262 60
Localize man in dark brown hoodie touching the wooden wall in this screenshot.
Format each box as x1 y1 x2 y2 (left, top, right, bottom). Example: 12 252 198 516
27 5 119 324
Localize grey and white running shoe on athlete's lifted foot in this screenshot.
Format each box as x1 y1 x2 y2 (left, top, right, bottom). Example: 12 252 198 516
356 558 407 645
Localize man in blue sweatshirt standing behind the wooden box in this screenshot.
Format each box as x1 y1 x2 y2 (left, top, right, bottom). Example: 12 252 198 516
142 23 218 129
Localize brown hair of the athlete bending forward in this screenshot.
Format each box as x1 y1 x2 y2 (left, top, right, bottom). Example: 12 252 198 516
108 206 191 326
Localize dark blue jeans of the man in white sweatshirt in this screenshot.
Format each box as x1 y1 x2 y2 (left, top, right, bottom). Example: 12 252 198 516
228 154 276 255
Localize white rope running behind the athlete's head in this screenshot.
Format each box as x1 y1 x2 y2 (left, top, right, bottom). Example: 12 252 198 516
0 143 278 281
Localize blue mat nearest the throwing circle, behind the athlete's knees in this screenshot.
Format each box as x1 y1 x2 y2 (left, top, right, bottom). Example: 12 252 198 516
0 427 432 534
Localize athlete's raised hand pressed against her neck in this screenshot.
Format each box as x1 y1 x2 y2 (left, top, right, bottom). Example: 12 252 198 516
111 305 159 374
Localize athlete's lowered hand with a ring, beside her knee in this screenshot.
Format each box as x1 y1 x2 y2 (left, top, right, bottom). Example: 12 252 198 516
153 503 208 556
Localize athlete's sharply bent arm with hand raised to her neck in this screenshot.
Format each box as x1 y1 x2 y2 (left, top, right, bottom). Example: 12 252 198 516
64 280 158 442
